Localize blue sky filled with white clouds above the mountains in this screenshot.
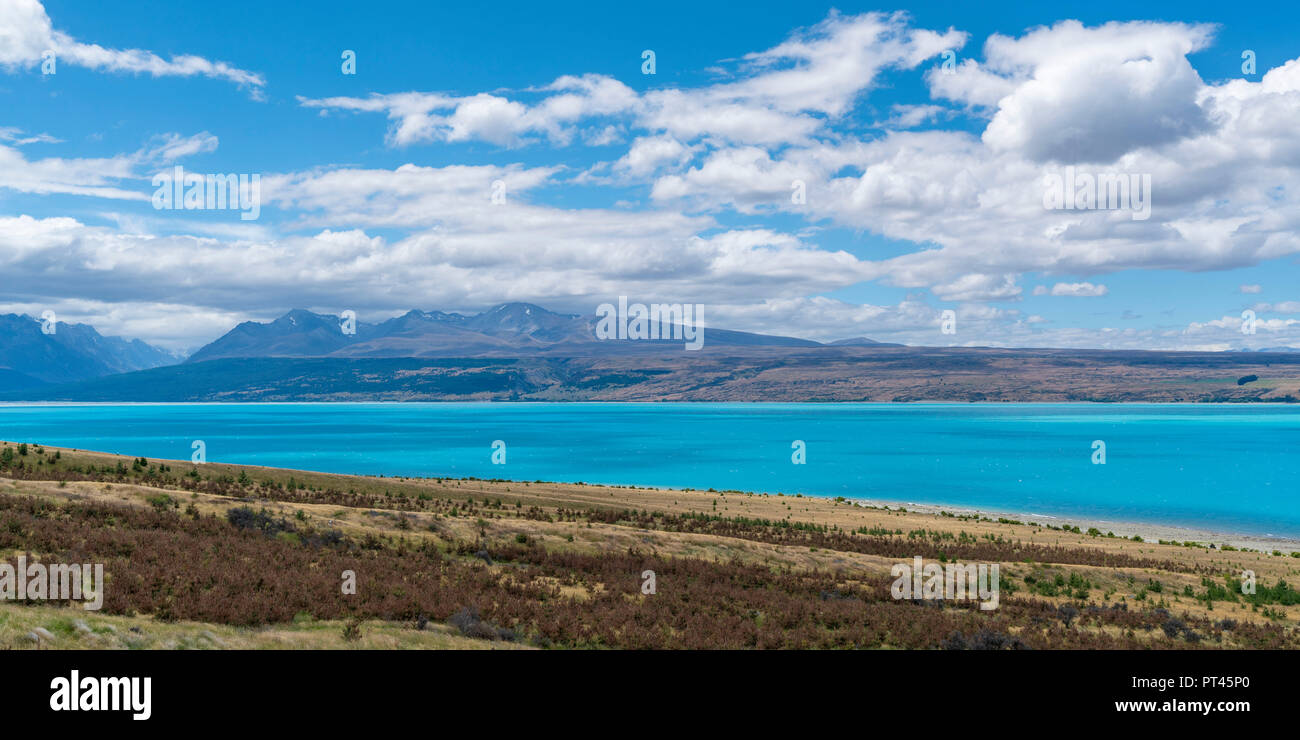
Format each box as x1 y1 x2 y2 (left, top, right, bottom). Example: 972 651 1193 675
0 0 1300 350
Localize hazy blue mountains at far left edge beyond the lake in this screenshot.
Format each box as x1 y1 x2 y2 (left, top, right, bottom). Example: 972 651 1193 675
0 313 178 389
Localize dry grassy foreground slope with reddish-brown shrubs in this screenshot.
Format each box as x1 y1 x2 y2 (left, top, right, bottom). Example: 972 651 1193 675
0 442 1300 649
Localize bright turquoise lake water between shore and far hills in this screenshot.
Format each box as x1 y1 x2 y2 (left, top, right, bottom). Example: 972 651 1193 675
0 403 1300 537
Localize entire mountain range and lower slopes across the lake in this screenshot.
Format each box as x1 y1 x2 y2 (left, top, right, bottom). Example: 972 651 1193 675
10 303 1300 402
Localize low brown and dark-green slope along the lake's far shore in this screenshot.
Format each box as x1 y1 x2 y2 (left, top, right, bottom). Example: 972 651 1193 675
10 343 1300 403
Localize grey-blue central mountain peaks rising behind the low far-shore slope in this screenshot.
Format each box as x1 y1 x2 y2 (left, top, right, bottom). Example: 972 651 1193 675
187 303 821 363
